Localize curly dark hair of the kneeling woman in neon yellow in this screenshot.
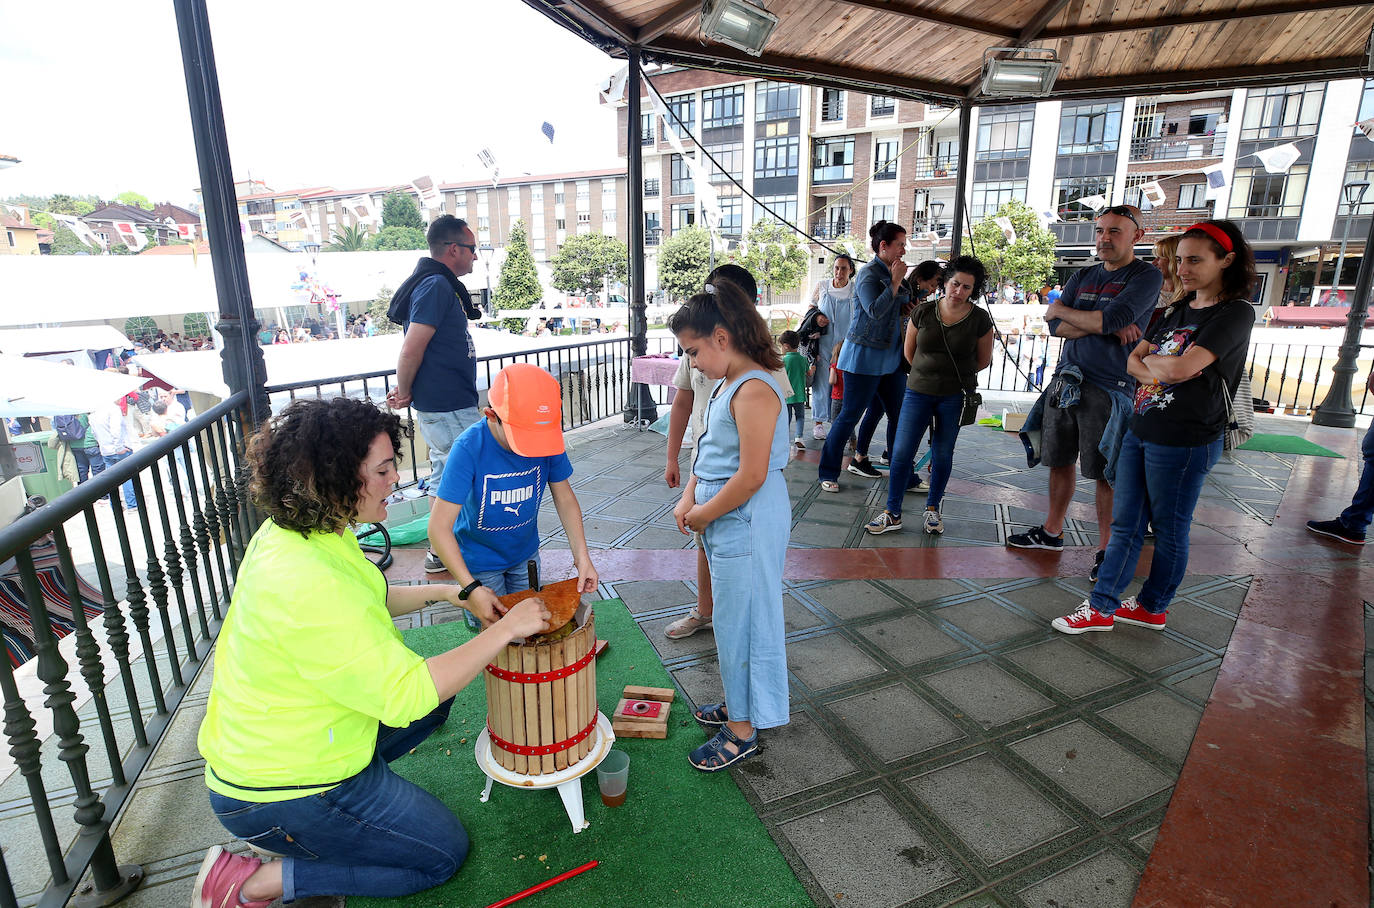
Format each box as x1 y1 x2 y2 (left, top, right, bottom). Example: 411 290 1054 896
249 397 411 536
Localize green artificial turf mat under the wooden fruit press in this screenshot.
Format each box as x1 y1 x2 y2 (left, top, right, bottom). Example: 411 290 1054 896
348 599 813 908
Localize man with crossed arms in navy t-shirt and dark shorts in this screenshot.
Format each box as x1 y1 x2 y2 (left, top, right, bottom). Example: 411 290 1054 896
1007 205 1164 581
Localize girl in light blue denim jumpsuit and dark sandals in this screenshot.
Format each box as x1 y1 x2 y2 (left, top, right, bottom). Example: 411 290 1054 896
668 282 791 772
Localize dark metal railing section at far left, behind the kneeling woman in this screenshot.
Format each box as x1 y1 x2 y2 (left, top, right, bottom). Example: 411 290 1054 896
0 393 260 905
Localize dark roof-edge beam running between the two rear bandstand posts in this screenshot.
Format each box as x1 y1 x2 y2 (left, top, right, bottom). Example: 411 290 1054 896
644 37 963 104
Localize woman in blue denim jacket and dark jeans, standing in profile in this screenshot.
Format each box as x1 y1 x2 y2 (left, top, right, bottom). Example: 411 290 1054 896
819 221 911 492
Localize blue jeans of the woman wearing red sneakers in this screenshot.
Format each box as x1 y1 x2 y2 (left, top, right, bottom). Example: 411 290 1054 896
1088 430 1221 615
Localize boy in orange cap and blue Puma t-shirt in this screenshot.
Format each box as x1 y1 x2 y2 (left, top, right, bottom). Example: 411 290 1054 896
429 363 598 621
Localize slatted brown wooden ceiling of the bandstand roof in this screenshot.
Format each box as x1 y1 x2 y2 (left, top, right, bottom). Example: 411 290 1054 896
525 0 1374 103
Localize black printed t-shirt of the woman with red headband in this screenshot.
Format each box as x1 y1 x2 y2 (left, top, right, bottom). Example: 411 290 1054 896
1131 299 1254 448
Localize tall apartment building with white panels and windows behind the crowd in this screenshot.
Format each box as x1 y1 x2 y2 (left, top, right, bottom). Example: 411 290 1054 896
620 69 1374 305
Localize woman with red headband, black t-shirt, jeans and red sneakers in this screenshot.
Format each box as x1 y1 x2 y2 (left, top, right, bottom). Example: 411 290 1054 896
1054 221 1256 633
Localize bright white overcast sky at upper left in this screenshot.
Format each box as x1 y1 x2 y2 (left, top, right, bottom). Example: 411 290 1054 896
0 0 621 205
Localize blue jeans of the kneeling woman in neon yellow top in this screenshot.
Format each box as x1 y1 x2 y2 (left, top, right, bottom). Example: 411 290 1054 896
210 698 469 903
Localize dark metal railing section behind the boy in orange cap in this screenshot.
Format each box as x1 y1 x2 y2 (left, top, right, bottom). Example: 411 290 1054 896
267 336 631 486
